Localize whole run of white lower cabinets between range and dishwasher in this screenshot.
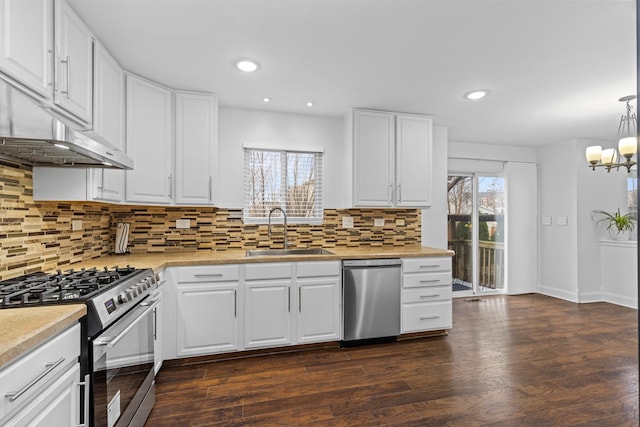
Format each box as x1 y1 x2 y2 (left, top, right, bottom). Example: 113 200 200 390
168 261 342 359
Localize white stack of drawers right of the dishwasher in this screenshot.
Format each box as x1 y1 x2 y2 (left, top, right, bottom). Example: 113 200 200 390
402 257 453 333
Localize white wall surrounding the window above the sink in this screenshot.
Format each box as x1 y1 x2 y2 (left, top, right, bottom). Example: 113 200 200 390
216 107 351 208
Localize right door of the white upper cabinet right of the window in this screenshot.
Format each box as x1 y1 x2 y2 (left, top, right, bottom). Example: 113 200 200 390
395 114 433 208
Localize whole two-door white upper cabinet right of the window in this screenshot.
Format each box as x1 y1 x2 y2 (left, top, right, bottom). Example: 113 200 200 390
353 110 433 208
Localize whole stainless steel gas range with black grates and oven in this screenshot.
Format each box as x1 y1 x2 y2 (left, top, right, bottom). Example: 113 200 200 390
0 266 159 427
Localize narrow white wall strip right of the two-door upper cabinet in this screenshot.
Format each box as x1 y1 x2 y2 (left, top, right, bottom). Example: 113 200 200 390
422 126 448 249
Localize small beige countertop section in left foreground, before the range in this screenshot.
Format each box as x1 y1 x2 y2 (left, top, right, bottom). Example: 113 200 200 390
0 304 87 367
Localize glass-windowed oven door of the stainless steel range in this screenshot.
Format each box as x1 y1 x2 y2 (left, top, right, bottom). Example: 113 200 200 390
91 297 159 427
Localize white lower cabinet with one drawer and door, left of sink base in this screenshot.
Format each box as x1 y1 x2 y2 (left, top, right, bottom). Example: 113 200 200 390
175 265 240 357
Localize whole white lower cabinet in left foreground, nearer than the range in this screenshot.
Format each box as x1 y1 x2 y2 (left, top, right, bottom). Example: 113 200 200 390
0 324 82 427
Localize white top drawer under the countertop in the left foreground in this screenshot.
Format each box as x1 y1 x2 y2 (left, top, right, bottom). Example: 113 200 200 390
0 323 80 419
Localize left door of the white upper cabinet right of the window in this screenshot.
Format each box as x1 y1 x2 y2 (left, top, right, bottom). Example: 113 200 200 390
353 110 395 206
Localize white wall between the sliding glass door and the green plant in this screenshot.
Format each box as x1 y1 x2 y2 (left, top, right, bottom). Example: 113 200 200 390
538 139 627 302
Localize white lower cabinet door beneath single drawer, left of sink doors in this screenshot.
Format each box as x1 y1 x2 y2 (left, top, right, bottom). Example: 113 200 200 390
177 284 238 356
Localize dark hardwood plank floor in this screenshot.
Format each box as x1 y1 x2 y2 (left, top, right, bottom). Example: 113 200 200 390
146 295 639 427
